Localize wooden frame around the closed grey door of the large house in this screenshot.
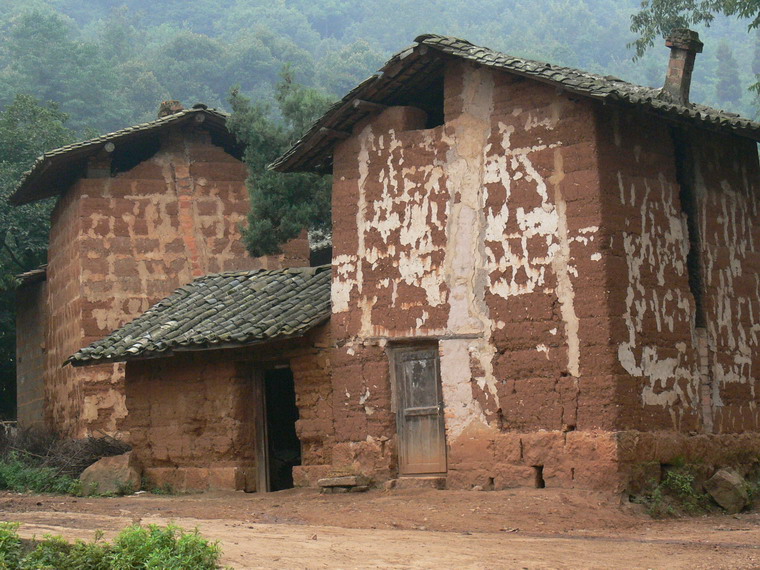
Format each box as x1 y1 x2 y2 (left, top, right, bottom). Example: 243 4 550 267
386 339 449 477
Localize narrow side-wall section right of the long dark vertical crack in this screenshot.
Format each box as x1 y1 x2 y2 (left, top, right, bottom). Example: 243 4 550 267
690 129 760 433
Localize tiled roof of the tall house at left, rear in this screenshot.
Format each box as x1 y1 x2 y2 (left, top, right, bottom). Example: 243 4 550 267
9 104 236 205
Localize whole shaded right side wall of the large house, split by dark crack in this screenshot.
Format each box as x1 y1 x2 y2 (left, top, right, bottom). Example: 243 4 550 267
599 107 760 434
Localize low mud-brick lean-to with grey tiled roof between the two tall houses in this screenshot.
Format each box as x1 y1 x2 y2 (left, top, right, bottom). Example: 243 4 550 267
69 266 332 491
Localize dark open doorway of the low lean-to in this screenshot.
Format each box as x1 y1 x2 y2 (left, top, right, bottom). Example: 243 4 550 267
264 368 301 491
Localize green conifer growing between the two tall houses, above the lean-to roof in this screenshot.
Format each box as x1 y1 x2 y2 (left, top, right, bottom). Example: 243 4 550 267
228 70 331 256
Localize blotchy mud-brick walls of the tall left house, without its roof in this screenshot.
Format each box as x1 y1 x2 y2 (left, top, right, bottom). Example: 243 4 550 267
40 124 309 436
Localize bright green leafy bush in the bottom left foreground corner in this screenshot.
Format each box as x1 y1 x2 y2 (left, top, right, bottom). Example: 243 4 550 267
0 523 221 570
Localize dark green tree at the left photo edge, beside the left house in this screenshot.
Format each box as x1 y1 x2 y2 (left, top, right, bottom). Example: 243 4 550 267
0 95 73 418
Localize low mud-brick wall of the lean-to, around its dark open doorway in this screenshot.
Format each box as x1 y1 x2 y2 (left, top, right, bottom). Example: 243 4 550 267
126 326 333 491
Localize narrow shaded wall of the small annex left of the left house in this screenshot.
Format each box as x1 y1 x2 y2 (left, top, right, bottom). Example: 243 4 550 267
16 281 47 428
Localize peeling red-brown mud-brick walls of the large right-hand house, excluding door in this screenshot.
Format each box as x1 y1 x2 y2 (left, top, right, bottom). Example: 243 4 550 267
332 62 760 491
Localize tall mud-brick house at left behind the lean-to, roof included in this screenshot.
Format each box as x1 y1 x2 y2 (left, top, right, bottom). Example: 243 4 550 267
11 102 308 436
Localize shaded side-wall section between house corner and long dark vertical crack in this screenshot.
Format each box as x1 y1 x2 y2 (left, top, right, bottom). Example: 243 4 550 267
599 110 700 431
